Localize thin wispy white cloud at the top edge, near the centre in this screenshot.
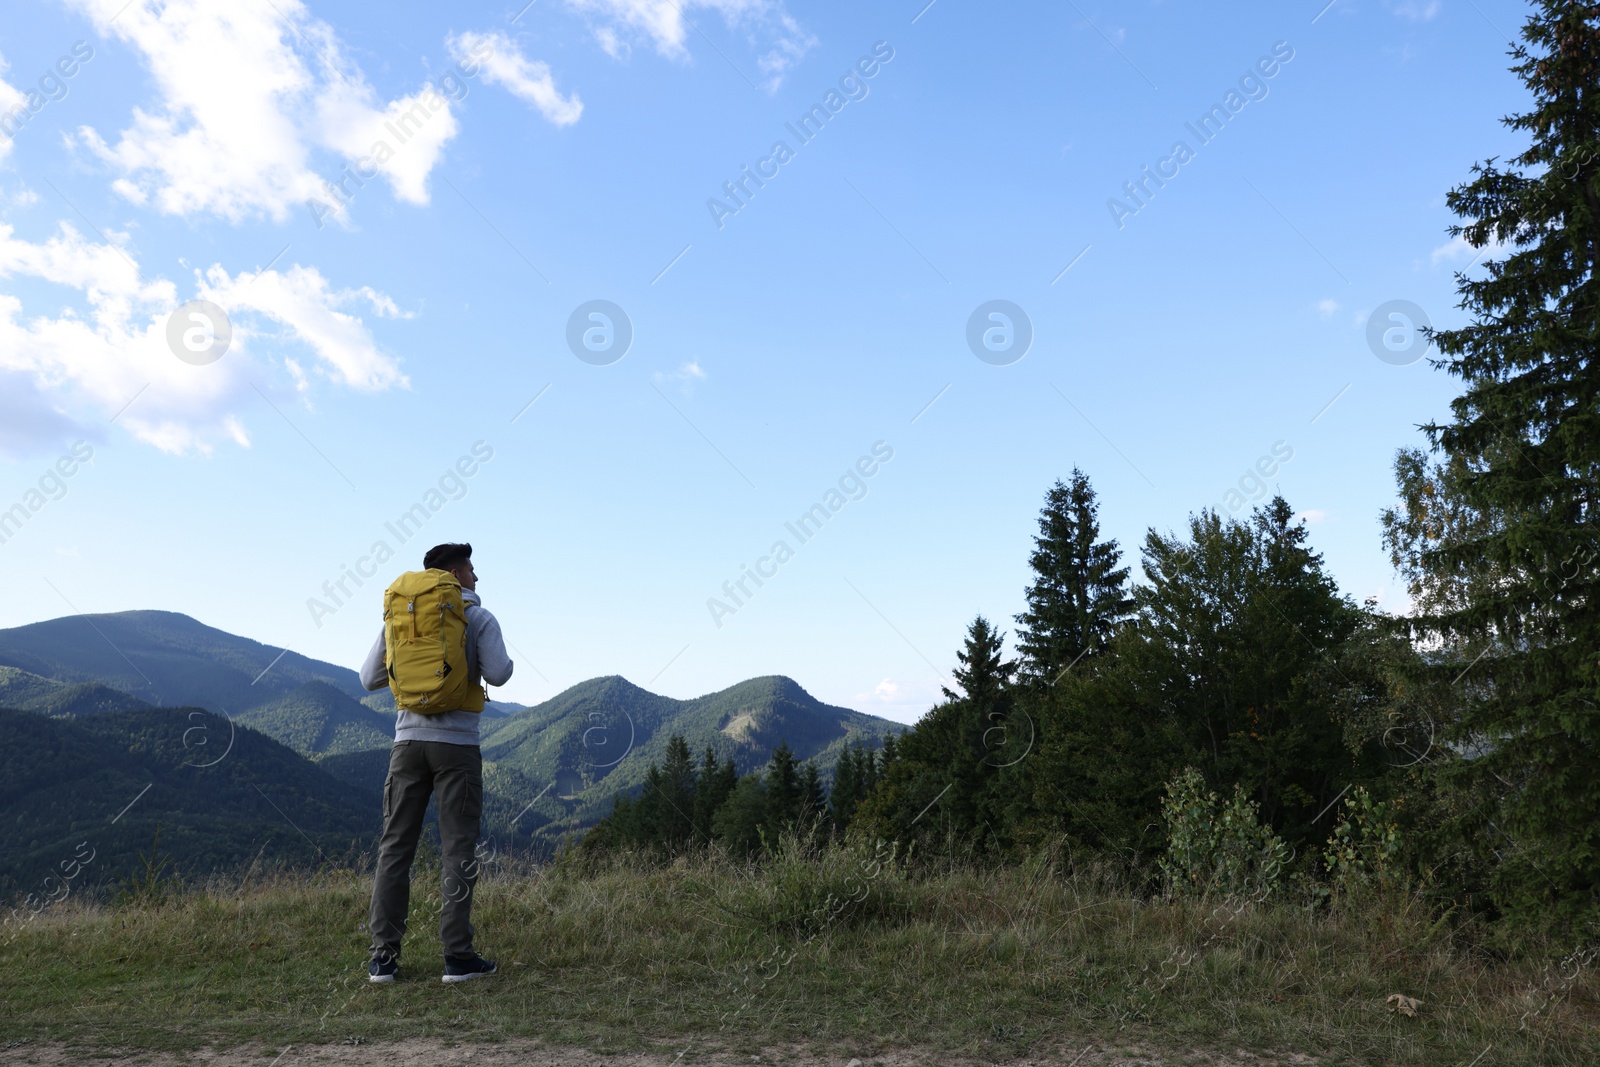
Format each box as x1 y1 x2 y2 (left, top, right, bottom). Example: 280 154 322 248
566 0 818 91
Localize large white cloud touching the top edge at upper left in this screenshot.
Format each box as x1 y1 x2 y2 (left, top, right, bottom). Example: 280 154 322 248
69 0 456 222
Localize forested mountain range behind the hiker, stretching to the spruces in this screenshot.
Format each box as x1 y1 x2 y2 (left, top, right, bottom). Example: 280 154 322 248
0 611 904 894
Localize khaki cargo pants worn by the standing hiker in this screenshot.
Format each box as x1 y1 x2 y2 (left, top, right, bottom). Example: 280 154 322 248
368 741 483 960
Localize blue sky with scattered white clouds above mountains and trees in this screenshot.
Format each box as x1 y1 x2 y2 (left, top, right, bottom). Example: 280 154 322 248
0 0 1526 721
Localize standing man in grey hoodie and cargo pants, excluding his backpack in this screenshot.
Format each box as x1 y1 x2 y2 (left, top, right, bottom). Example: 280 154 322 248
362 544 512 982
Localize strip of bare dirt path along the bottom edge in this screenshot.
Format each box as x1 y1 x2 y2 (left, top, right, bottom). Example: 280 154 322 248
0 1038 1317 1067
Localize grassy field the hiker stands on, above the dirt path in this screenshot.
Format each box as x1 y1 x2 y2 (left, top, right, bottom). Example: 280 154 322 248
0 846 1600 1067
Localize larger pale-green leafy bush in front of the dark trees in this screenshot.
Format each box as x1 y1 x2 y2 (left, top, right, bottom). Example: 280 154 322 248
1162 766 1290 899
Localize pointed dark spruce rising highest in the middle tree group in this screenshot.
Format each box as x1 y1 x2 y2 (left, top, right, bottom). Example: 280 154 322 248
1016 467 1133 683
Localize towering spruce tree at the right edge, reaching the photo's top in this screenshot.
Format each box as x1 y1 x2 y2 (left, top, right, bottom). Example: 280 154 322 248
1384 0 1600 925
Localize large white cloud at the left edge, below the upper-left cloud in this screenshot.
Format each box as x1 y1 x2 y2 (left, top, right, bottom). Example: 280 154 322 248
0 222 406 453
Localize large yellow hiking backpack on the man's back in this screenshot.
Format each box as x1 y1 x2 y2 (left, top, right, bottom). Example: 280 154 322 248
384 571 488 715
